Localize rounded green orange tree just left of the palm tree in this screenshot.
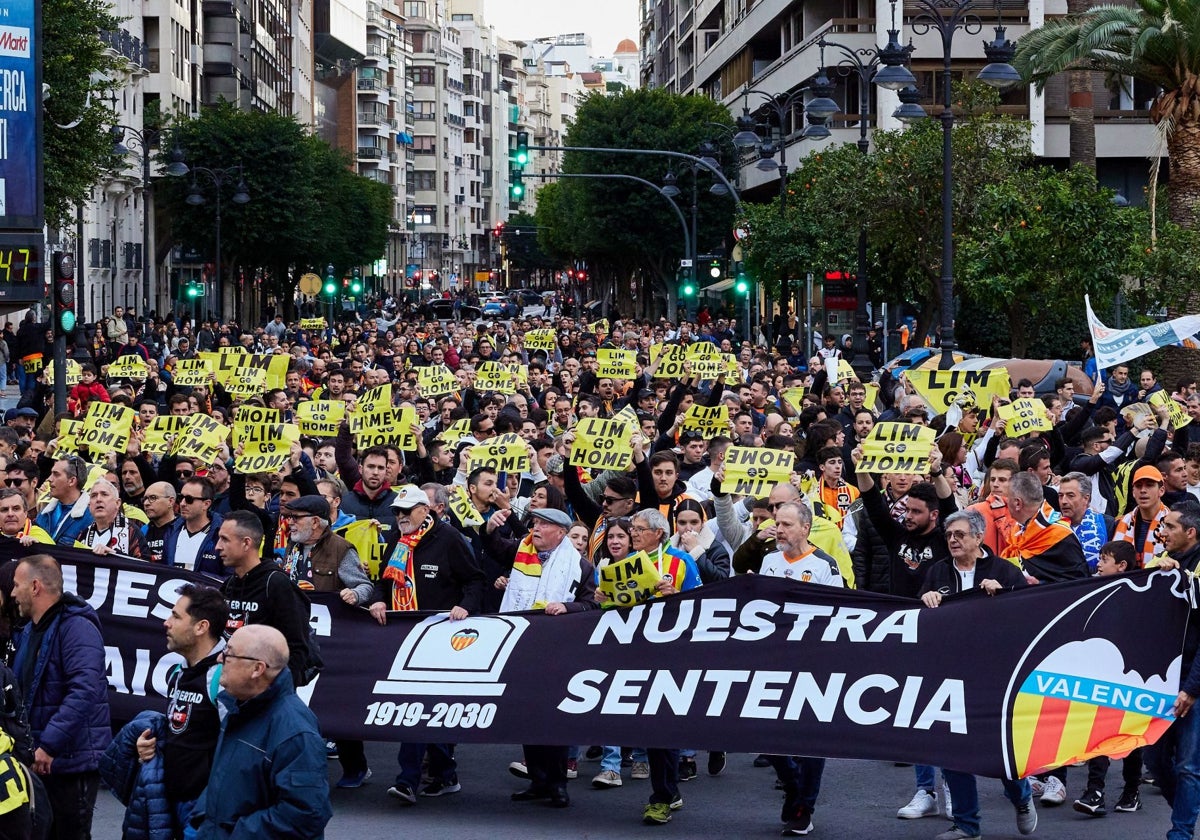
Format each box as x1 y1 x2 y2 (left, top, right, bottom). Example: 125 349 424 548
955 167 1132 356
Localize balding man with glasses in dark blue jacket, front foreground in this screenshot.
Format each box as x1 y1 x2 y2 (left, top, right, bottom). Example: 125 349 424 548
191 624 334 840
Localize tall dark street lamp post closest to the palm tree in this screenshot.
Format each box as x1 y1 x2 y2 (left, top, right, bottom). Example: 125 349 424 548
911 0 1021 370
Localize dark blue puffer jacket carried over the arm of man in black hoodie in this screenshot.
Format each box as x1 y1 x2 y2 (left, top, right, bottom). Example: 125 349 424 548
100 712 174 840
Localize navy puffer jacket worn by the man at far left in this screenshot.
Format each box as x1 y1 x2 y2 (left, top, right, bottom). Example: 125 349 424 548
12 593 113 773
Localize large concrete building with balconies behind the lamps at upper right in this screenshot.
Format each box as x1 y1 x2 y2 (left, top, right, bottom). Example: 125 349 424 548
640 0 1154 200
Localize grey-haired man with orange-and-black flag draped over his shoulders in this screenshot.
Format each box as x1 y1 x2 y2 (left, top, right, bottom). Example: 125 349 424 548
1006 472 1088 583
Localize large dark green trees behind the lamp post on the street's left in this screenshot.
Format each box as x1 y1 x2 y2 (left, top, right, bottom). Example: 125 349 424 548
160 102 392 280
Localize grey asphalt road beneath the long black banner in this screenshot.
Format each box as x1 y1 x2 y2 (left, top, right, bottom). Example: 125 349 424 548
94 744 1169 840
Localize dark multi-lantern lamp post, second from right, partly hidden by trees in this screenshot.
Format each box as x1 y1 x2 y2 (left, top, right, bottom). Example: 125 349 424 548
809 9 917 382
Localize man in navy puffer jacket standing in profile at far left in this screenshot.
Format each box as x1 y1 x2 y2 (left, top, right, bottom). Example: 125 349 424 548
12 554 112 840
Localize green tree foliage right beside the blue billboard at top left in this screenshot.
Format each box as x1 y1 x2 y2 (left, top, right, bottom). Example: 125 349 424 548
42 0 125 227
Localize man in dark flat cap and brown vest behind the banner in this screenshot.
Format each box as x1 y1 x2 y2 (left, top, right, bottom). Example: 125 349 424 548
280 496 383 788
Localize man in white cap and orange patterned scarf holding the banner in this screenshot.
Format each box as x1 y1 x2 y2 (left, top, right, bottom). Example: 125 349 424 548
371 484 486 805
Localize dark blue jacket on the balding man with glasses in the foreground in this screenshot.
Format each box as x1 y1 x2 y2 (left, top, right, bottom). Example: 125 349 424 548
188 671 334 840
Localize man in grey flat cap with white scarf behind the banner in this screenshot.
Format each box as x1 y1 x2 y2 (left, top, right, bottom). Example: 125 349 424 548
485 508 599 808
